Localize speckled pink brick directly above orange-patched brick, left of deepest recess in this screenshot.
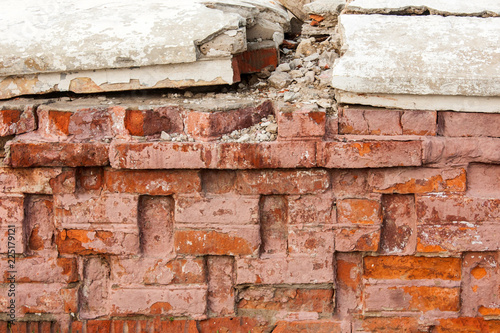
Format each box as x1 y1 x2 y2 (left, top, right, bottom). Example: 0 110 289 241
54 193 139 229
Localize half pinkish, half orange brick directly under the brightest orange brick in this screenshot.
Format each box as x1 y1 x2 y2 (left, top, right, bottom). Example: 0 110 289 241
364 285 460 312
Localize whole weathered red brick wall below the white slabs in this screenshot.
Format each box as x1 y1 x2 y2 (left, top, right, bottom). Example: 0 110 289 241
0 101 500 333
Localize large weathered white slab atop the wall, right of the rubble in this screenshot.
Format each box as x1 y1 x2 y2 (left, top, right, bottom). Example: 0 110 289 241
332 15 500 98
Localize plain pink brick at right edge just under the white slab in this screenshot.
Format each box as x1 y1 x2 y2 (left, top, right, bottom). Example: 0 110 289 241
439 111 500 138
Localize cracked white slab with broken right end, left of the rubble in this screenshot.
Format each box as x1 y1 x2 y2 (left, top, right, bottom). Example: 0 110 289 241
0 0 289 99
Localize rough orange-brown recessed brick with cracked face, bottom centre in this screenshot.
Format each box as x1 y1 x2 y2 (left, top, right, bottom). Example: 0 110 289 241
238 286 334 314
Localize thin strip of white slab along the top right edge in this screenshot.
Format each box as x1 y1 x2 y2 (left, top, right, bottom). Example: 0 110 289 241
346 0 500 16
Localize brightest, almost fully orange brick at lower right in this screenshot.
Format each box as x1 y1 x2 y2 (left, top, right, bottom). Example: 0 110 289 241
363 256 462 281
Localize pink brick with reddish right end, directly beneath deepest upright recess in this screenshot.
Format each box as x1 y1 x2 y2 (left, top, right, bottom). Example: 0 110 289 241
110 257 207 286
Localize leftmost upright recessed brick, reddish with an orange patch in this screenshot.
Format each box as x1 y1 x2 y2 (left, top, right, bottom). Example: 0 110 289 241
24 195 55 255
